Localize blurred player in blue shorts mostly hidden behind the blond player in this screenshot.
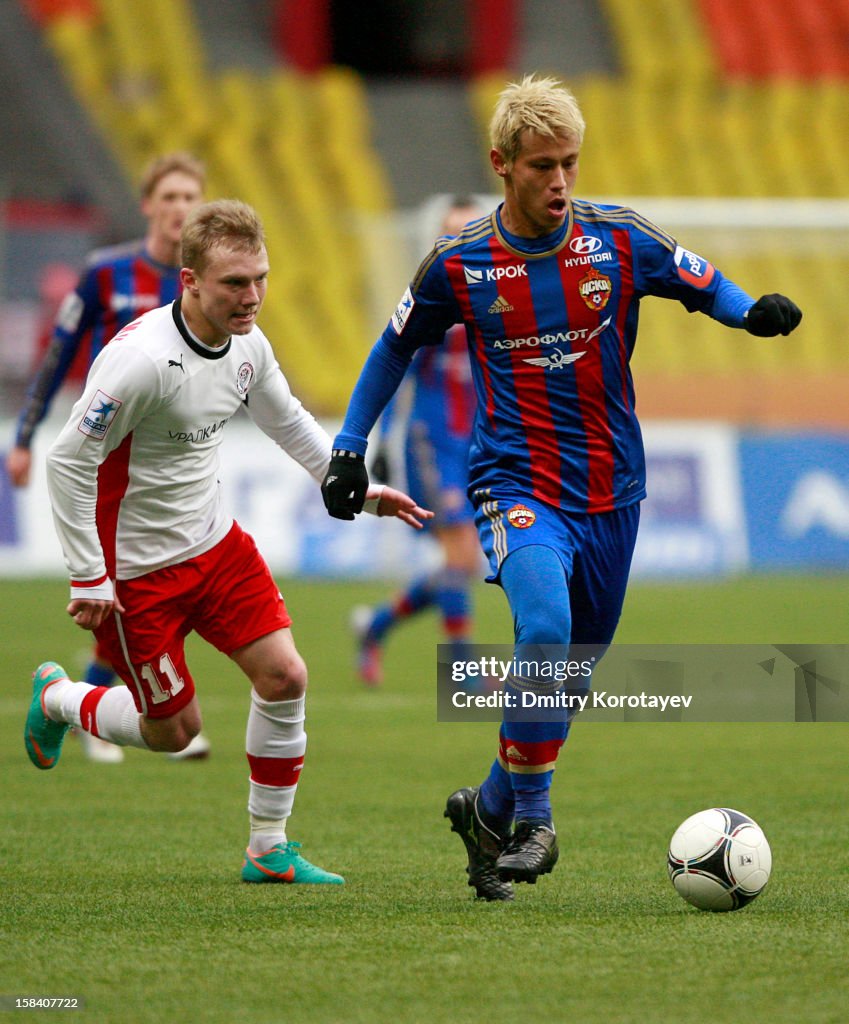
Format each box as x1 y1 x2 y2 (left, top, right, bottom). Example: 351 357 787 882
351 196 483 686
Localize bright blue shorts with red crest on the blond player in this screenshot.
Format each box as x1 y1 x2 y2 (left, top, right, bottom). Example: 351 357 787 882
475 490 640 643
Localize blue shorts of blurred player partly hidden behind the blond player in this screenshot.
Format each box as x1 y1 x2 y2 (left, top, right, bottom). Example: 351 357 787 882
406 420 474 527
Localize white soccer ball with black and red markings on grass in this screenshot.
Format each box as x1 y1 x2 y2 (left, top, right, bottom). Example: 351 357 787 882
667 807 772 910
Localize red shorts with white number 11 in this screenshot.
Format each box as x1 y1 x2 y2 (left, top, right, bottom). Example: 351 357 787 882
94 523 292 718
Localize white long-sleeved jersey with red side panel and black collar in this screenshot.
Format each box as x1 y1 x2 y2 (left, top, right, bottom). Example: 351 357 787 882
47 299 331 599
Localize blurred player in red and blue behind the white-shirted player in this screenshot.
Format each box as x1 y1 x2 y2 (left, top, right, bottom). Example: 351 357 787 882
6 153 209 762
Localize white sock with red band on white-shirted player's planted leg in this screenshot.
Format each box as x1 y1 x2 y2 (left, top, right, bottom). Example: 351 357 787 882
245 689 306 853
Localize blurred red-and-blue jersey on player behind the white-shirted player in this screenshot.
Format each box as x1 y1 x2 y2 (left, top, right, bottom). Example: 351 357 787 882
15 241 180 447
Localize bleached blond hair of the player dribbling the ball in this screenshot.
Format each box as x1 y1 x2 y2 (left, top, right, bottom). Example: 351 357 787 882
490 75 586 165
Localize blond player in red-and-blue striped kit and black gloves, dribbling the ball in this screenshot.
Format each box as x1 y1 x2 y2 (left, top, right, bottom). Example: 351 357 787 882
324 76 802 900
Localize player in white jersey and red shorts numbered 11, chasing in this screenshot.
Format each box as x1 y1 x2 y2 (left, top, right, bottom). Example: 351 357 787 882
25 200 431 885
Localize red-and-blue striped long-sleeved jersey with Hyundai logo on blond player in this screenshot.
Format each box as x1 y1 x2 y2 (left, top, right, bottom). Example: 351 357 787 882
334 200 754 513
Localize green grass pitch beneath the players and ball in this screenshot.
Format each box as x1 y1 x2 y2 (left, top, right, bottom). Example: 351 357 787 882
0 577 849 1024
